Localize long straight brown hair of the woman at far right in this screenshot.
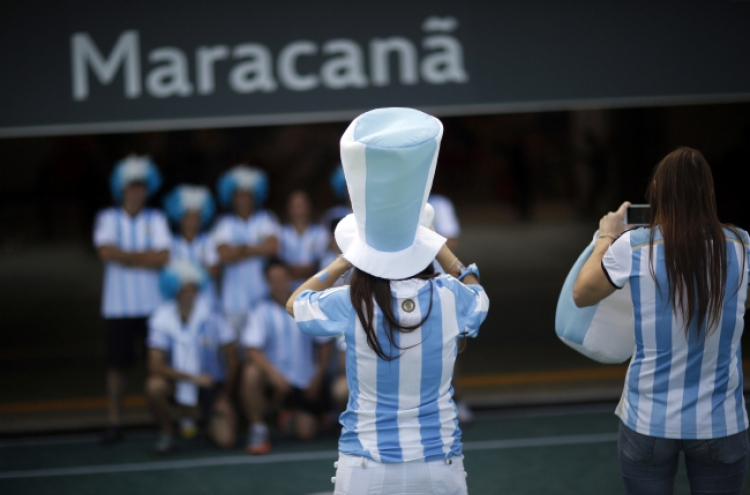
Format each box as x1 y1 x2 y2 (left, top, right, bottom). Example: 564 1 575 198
646 148 745 335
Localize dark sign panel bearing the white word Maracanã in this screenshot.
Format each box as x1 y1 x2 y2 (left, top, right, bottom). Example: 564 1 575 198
0 0 750 137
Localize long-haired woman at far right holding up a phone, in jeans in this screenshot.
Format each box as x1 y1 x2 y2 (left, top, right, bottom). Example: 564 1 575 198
573 148 750 495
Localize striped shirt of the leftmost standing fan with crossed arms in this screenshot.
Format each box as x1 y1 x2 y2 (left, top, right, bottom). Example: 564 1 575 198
94 208 172 318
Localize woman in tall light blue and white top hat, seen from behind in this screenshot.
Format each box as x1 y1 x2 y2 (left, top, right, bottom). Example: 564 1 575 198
287 108 489 494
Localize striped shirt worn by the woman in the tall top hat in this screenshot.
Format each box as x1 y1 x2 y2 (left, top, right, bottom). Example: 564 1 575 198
294 275 489 463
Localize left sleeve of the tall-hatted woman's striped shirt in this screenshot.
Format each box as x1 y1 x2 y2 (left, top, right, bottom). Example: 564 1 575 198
294 286 354 337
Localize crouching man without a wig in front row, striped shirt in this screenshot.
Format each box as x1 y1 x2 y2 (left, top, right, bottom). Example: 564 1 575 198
241 259 331 454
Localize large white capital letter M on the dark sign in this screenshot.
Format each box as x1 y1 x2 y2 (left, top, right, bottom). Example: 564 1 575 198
70 31 141 101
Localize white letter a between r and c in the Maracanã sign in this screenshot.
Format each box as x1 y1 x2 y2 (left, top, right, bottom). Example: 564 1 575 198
229 43 277 93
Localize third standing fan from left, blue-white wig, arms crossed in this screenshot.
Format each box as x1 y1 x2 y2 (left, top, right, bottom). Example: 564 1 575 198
213 165 279 335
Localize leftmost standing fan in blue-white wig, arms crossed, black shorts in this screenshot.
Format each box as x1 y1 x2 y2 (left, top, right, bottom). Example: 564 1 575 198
94 155 171 443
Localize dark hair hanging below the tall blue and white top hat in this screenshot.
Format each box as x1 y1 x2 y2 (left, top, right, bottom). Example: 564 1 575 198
349 263 436 361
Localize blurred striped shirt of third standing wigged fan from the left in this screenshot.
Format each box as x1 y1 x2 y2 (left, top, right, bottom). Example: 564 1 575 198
213 210 279 314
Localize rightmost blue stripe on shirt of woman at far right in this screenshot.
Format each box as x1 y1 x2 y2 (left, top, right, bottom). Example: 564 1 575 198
711 242 740 438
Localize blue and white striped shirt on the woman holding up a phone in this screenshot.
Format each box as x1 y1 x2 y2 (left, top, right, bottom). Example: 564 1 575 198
602 228 750 439
